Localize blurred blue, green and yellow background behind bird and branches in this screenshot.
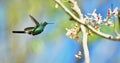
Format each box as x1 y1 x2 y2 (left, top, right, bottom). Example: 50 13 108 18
0 0 120 63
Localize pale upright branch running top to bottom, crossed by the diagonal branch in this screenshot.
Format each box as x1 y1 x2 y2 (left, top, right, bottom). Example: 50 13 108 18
69 0 90 63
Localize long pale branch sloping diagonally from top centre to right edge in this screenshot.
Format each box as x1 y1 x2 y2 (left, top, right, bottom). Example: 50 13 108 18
55 0 120 41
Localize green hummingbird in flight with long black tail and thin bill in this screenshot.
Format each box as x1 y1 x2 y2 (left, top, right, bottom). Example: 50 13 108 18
12 15 53 36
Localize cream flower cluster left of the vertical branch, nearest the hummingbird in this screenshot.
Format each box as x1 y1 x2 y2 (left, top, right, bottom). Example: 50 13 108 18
66 24 80 41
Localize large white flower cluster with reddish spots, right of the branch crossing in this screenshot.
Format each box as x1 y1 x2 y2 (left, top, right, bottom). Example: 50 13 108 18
84 7 118 29
